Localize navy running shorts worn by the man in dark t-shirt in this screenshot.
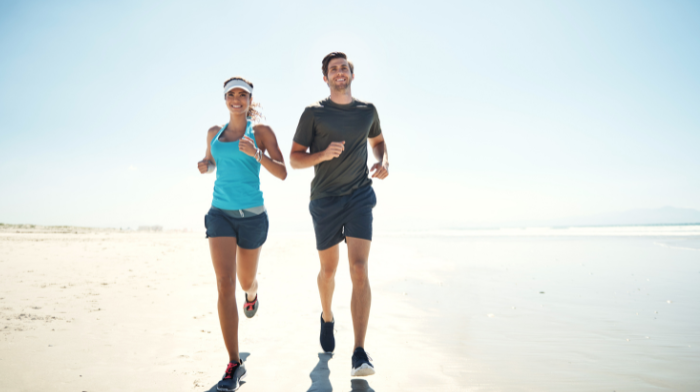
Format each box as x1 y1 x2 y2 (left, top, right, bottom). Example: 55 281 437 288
309 186 377 250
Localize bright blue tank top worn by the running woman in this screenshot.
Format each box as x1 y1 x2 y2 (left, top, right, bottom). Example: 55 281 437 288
211 120 265 210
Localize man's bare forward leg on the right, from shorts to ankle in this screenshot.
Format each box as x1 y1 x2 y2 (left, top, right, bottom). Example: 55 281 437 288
347 237 372 348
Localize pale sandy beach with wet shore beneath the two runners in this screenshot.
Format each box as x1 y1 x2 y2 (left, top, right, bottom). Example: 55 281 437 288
0 225 700 392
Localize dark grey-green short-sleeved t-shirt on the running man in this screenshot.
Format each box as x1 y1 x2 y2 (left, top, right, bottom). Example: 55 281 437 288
294 98 382 200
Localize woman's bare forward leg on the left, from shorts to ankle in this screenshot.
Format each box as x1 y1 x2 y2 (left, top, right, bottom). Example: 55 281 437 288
209 237 240 362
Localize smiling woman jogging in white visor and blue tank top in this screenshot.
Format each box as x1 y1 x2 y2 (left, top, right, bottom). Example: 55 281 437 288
197 77 287 391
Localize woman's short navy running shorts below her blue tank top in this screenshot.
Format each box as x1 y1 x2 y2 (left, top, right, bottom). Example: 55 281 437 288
204 208 270 249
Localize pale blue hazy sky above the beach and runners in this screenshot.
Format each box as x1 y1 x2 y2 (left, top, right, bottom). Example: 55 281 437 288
0 0 700 230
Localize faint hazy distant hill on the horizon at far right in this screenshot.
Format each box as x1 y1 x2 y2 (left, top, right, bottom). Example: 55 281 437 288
507 207 700 226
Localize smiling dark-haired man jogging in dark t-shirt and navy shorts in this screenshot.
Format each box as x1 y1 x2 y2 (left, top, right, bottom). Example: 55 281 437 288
290 52 389 376
